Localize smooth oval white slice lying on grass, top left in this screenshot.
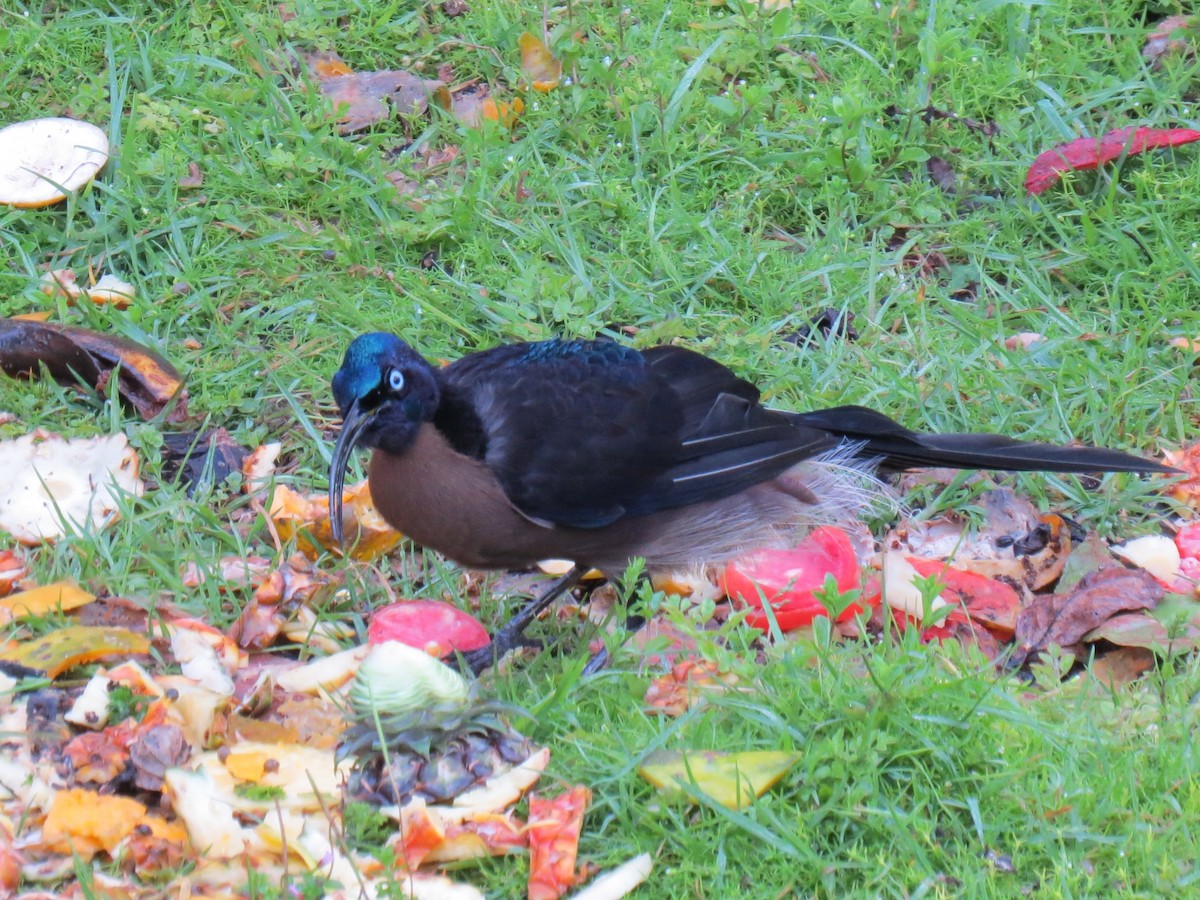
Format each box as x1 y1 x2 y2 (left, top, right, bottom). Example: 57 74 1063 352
0 118 108 208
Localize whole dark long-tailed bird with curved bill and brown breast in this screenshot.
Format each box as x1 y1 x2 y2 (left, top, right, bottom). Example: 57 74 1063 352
329 331 1172 674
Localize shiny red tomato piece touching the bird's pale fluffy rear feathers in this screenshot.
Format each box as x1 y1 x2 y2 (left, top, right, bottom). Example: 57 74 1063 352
721 526 863 631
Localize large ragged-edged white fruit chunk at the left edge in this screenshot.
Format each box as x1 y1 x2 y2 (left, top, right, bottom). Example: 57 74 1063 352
0 430 145 545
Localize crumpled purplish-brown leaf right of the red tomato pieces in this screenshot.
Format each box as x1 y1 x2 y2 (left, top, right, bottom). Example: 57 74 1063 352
1013 566 1163 665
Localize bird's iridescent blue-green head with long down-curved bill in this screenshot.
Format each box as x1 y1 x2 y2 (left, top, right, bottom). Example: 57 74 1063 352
329 331 440 544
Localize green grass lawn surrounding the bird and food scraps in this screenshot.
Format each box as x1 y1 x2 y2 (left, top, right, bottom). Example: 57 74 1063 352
0 0 1200 898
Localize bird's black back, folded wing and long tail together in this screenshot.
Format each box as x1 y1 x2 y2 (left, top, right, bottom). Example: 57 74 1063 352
434 341 1166 528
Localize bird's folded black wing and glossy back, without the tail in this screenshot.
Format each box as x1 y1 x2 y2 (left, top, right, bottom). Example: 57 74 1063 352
442 341 836 528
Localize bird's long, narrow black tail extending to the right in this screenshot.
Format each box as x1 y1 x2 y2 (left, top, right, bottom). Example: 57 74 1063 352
794 406 1176 474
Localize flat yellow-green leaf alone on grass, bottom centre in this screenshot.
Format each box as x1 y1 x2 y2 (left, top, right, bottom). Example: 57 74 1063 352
637 750 800 809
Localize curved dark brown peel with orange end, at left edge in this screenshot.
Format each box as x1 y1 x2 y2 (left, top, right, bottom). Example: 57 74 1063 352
0 318 187 421
